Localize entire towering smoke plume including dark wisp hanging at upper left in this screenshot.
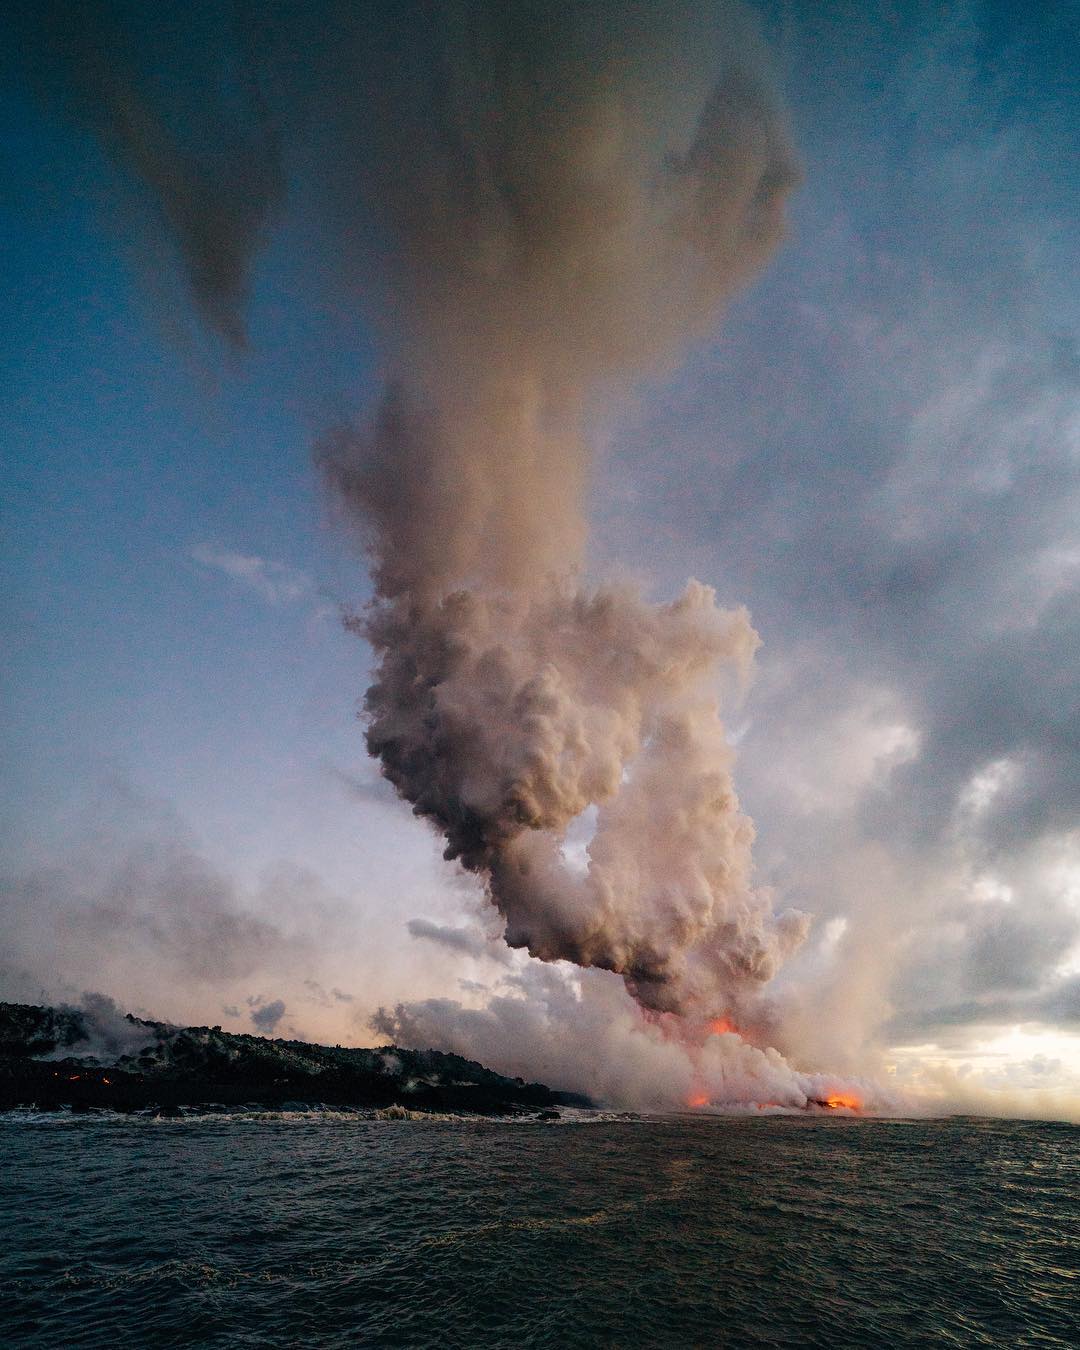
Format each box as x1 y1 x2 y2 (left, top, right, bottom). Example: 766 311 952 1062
23 0 807 1017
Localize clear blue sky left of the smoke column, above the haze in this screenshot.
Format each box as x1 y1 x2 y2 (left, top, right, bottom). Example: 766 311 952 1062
4 78 371 867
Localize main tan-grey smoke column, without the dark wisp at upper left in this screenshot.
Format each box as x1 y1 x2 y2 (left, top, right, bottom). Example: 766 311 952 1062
323 3 806 1014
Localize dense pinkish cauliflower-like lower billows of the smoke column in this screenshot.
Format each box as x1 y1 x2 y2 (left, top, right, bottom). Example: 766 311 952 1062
341 582 803 1011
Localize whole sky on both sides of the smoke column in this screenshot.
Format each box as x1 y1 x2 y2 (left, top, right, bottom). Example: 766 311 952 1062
0 3 1080 1110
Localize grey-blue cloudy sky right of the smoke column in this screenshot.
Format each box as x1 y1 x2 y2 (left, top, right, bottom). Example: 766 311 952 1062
598 4 1080 1053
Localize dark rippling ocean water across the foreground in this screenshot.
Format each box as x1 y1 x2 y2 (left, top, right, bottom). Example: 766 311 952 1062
0 1116 1080 1347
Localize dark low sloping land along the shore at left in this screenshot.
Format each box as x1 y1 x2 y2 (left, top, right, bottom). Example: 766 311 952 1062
0 1000 591 1116
